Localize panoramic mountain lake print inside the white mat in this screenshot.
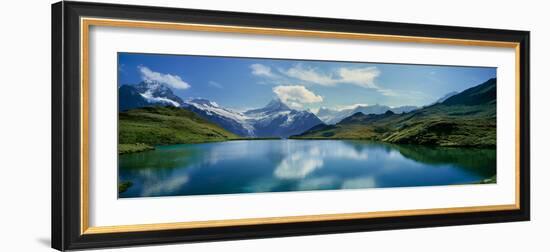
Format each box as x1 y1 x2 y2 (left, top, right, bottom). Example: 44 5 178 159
117 53 497 198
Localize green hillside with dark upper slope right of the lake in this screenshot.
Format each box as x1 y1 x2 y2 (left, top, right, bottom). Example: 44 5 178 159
292 79 496 147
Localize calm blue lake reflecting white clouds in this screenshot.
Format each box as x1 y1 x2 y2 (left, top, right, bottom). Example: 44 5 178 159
118 140 496 198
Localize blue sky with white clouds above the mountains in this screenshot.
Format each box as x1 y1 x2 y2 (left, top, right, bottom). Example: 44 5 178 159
118 53 496 110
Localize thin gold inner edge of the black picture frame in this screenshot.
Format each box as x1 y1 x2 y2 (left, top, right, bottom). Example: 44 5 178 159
80 17 521 235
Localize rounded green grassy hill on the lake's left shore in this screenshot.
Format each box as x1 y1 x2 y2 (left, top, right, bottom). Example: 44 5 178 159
118 107 237 153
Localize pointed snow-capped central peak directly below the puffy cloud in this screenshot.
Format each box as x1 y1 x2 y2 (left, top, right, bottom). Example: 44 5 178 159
244 99 323 137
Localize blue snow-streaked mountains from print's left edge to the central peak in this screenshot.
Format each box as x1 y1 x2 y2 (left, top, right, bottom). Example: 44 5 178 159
119 81 323 138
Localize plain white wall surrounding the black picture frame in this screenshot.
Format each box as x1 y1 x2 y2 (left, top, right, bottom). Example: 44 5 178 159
0 0 550 252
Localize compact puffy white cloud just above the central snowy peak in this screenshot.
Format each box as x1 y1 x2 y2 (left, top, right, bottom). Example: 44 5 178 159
273 85 323 108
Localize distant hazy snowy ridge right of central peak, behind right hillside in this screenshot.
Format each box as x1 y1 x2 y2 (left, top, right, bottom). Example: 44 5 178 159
316 104 418 124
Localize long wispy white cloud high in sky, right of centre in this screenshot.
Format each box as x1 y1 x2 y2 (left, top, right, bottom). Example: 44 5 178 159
282 65 380 89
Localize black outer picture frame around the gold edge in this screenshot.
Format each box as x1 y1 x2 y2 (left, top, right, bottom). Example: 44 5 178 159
51 1 530 251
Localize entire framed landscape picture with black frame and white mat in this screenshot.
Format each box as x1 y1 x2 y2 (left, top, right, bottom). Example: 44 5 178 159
52 1 529 250
